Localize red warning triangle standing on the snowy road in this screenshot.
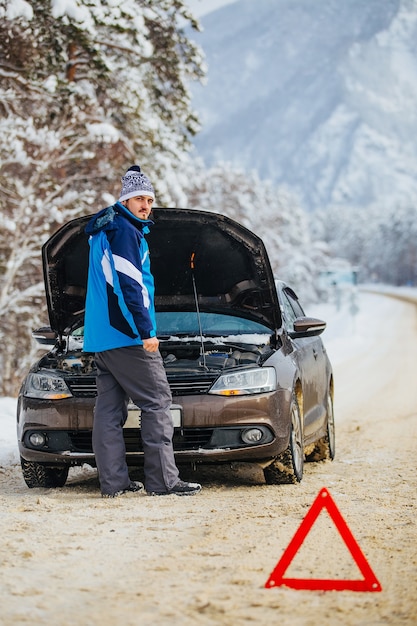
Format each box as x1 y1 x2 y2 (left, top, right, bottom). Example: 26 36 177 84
265 488 382 591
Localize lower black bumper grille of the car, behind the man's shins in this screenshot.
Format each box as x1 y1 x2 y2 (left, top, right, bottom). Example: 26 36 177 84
68 428 213 452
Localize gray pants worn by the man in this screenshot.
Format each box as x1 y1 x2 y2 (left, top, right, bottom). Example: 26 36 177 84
93 346 178 493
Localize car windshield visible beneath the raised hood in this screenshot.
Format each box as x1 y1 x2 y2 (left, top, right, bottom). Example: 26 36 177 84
156 311 271 336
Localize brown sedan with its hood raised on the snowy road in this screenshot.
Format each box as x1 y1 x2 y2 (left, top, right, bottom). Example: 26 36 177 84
17 208 335 488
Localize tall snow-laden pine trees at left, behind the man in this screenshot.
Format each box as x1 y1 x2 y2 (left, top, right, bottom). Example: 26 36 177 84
0 0 203 393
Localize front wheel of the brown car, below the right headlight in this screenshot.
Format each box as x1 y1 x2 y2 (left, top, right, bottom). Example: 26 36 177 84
264 395 304 485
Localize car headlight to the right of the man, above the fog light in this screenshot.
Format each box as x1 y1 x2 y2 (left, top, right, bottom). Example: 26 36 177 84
209 367 277 396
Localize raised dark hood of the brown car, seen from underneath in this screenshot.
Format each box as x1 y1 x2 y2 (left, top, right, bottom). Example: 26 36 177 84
42 208 281 335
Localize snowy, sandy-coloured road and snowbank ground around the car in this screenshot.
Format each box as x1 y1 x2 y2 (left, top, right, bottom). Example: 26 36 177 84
0 293 417 626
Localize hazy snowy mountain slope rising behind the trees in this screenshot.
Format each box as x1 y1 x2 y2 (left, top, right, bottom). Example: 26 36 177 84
193 0 417 209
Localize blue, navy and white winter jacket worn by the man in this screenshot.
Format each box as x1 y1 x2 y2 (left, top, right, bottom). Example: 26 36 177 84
84 202 156 352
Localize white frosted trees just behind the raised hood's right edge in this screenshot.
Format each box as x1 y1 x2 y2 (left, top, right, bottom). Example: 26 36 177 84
177 160 326 302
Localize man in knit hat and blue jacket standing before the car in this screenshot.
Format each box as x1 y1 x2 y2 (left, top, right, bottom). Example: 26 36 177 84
84 165 201 497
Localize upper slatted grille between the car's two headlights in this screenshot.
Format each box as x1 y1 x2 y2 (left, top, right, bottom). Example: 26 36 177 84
66 373 218 398
